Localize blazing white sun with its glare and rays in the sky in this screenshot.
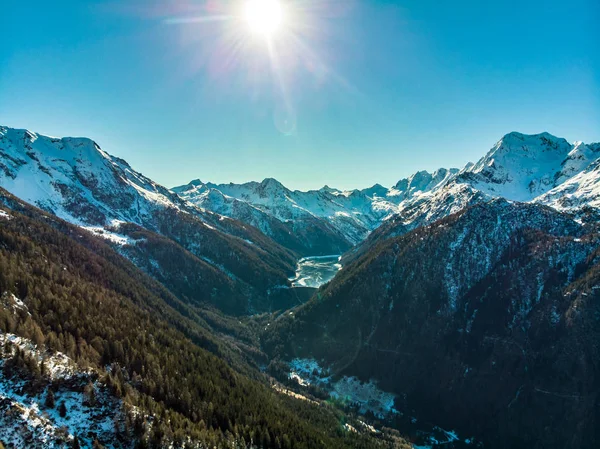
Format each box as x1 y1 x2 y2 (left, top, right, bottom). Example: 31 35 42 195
158 0 360 136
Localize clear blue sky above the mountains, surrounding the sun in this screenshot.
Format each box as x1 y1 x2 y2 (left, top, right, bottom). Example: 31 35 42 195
0 0 600 189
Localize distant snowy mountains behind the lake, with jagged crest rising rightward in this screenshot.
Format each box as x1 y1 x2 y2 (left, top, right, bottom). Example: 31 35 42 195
172 169 458 255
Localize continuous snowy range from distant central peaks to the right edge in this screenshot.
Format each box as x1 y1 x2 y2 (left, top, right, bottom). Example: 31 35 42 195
173 132 600 252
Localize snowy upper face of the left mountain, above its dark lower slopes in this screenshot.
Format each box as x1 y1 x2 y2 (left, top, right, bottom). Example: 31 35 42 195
0 127 186 226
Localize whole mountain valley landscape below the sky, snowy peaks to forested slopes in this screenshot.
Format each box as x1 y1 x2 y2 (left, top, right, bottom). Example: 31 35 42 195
0 127 600 449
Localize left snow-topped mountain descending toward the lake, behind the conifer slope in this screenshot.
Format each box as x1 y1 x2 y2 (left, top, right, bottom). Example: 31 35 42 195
0 127 297 314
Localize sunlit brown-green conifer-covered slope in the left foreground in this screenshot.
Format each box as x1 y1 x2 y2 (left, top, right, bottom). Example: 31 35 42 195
0 189 398 448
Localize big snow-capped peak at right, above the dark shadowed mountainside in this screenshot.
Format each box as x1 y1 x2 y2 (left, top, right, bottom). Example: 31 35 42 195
346 132 600 260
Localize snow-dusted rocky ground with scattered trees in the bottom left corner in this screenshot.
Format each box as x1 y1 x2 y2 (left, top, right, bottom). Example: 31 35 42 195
0 332 126 449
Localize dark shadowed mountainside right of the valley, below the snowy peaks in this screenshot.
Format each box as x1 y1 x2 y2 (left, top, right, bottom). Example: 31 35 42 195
265 199 600 448
